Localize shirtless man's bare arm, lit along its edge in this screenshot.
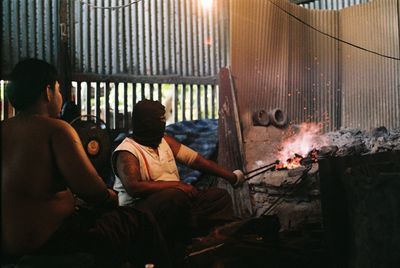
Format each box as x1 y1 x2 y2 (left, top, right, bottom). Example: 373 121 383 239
51 120 118 206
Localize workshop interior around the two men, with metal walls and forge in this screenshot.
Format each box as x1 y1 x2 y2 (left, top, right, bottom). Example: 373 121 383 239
0 0 400 268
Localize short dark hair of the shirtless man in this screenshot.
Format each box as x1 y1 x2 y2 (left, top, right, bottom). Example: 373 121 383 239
6 59 58 110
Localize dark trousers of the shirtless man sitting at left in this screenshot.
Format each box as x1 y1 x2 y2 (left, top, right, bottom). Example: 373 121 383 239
37 207 178 267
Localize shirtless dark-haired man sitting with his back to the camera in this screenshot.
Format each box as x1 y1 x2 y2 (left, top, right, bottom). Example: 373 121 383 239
1 59 183 262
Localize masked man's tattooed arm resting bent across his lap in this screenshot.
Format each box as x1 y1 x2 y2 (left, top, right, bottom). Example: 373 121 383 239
116 151 197 197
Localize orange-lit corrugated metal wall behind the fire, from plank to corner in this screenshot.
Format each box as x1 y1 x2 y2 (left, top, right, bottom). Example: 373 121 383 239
231 0 338 134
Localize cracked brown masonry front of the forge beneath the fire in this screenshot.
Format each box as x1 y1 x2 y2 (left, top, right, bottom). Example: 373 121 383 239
250 164 321 230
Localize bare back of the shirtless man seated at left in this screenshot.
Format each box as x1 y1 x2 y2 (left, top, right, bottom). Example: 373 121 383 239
1 115 111 253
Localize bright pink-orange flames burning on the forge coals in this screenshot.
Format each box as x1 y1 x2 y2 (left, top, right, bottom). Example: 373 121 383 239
276 123 328 169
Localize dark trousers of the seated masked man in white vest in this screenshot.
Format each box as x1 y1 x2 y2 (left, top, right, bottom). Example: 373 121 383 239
134 187 233 239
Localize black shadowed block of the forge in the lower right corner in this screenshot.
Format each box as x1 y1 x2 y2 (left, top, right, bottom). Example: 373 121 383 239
319 151 400 267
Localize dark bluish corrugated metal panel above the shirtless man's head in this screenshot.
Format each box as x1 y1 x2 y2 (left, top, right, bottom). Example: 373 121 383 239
0 0 60 75
